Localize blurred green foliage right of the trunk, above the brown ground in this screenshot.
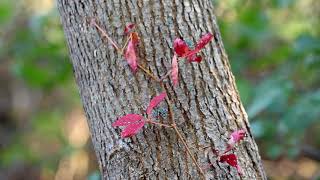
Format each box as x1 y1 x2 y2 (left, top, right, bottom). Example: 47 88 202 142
219 0 320 159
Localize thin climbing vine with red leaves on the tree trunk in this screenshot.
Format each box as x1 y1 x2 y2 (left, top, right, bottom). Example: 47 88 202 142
90 19 245 178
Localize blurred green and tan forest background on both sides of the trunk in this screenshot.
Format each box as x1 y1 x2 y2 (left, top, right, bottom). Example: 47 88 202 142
0 0 320 180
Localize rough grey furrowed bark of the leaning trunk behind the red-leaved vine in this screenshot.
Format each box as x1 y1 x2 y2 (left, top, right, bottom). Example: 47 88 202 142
58 0 266 180
